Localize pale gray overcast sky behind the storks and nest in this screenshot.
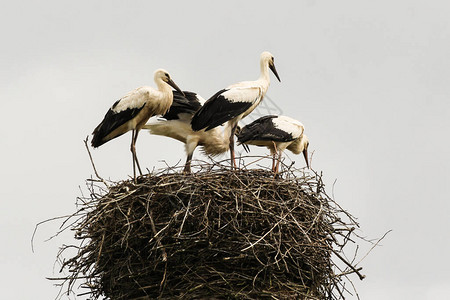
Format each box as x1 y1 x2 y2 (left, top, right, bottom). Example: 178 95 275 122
0 0 450 300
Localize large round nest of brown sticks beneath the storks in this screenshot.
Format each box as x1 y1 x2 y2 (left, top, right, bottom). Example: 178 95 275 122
54 159 362 299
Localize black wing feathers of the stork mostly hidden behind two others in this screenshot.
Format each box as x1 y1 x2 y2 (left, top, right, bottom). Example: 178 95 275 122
163 91 202 120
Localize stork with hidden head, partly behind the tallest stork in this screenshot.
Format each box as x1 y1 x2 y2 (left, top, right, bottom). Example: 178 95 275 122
142 91 237 173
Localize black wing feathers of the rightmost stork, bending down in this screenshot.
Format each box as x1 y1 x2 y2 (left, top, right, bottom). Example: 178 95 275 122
238 115 294 144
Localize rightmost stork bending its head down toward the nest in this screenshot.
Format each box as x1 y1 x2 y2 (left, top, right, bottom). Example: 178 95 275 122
238 115 309 174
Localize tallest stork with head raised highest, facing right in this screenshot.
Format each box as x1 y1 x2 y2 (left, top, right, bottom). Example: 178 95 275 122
191 51 281 168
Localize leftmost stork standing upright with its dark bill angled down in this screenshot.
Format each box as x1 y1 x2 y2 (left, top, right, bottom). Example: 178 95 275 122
91 69 182 181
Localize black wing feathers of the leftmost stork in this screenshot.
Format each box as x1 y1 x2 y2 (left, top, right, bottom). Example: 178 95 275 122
91 100 145 148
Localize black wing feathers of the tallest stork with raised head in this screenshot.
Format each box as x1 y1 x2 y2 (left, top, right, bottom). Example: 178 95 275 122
191 89 252 131
